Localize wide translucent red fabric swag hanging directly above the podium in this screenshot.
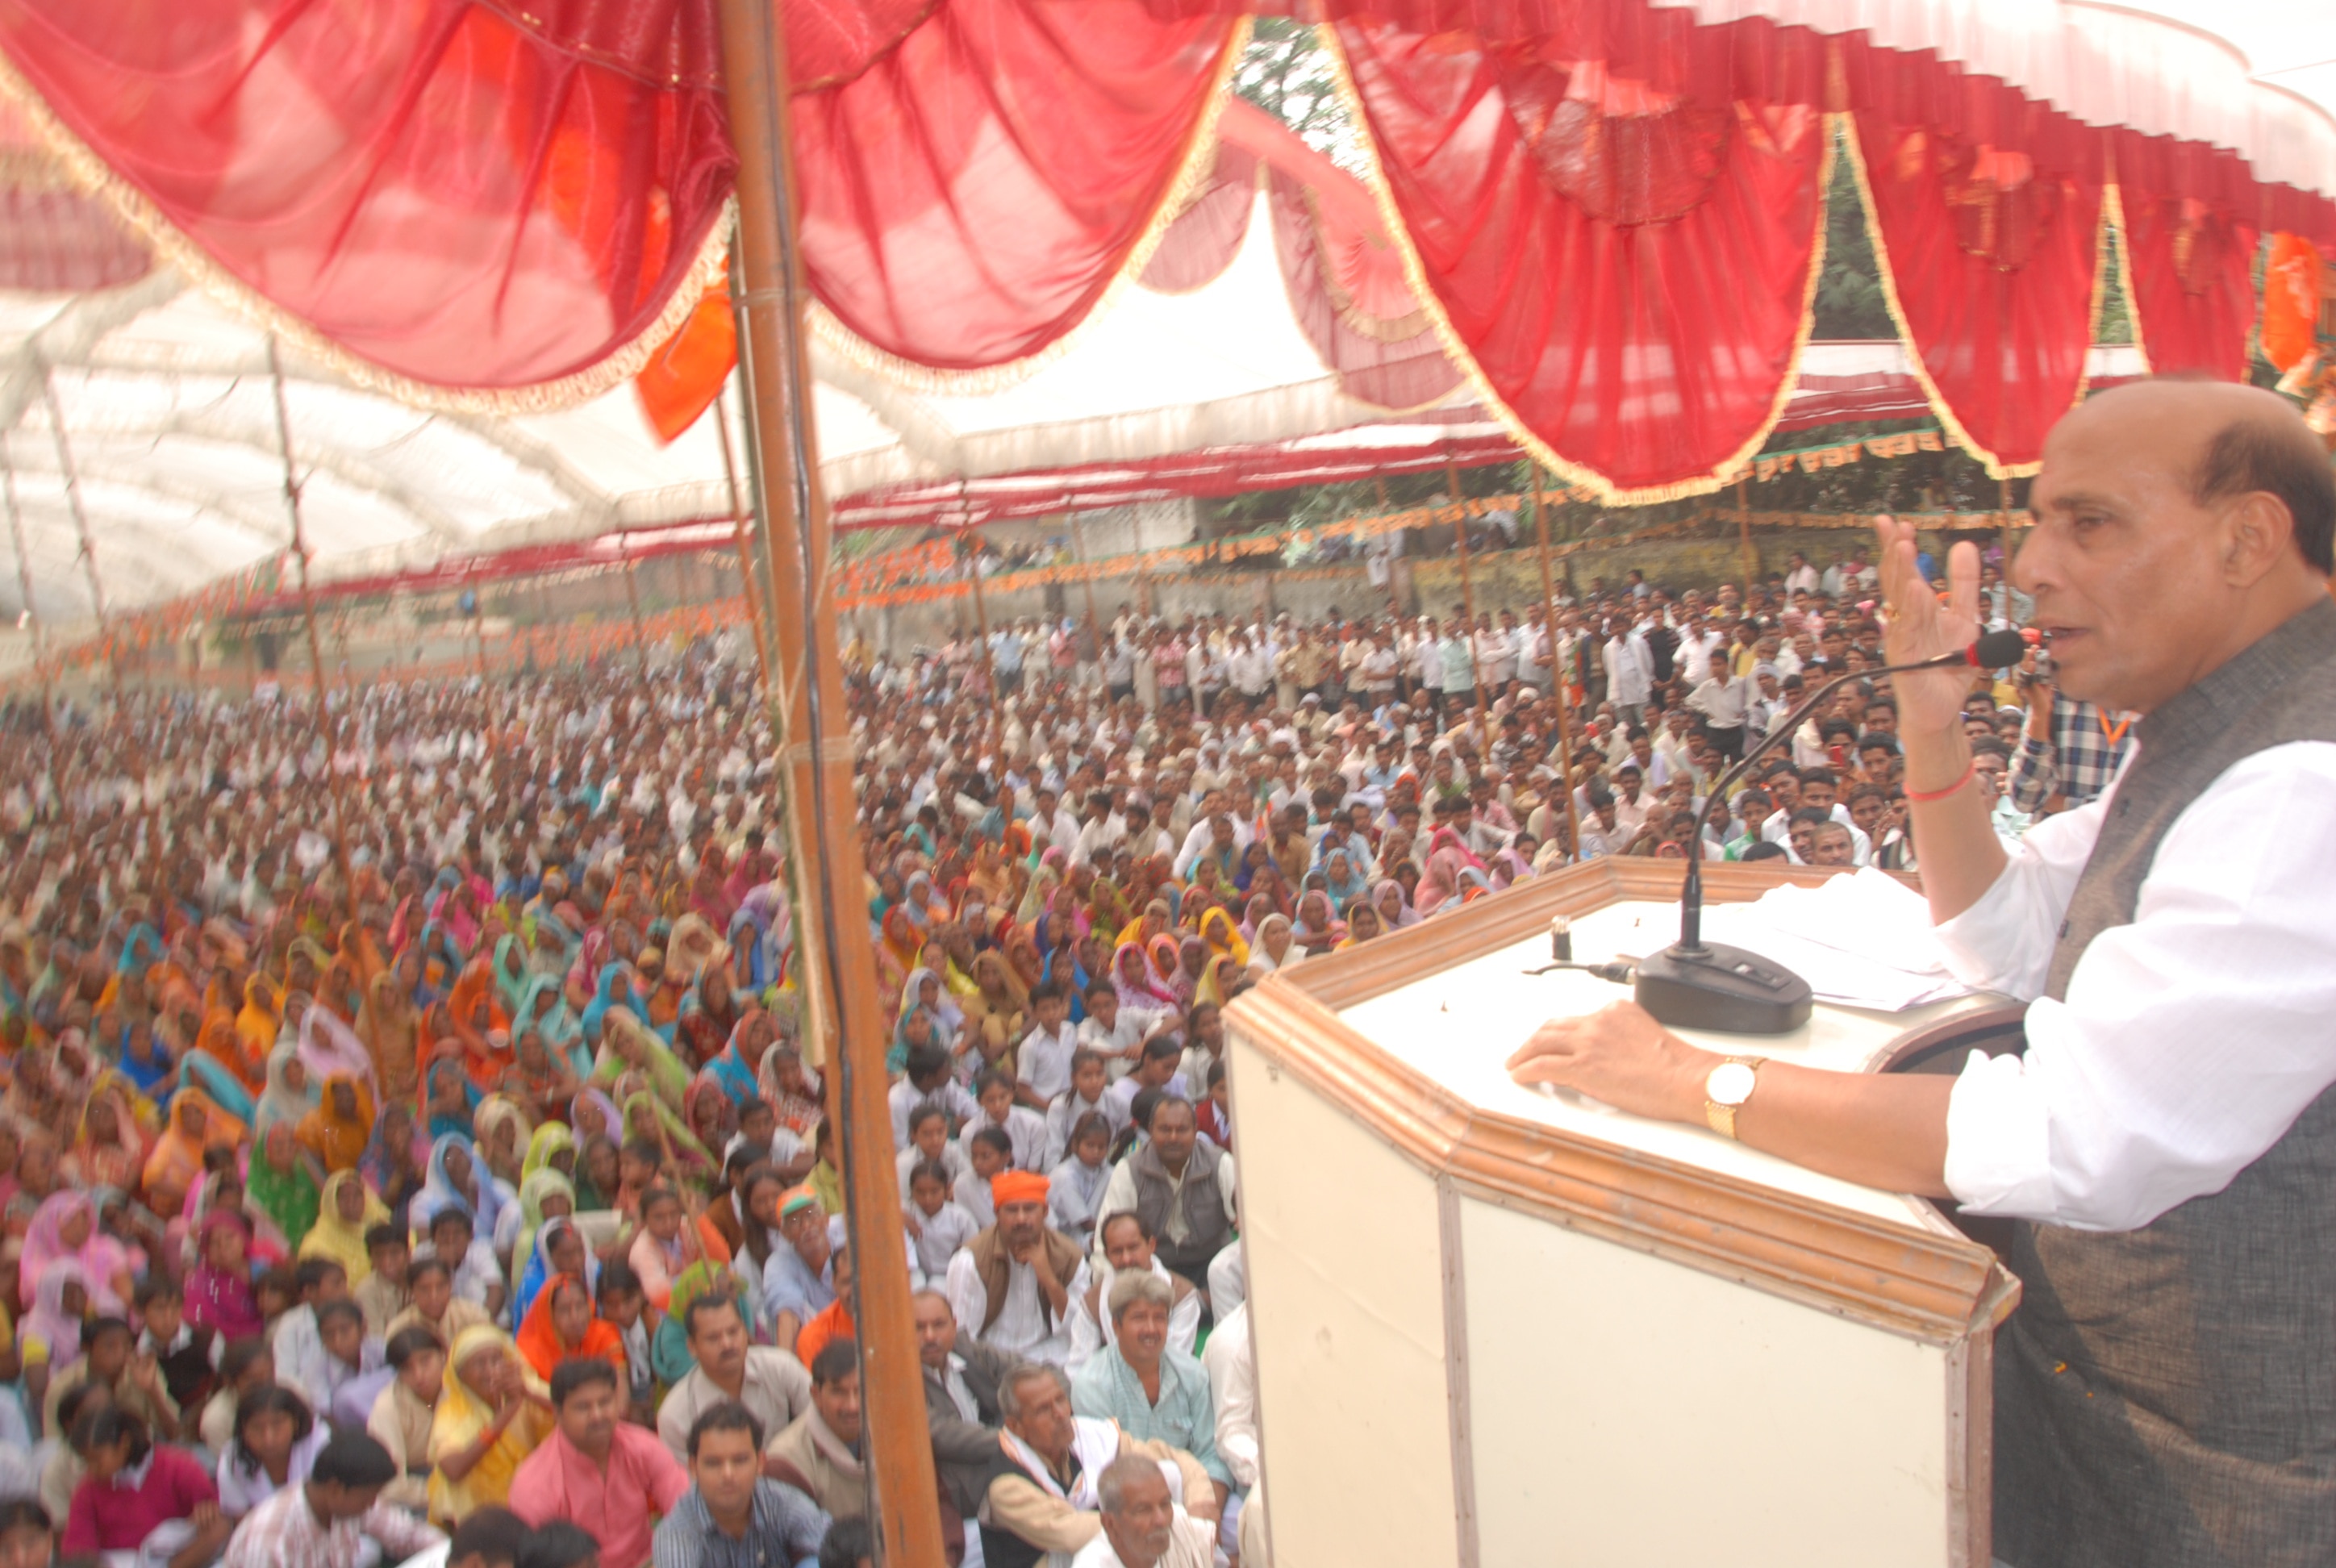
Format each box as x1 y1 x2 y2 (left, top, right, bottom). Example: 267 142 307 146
1338 0 1827 500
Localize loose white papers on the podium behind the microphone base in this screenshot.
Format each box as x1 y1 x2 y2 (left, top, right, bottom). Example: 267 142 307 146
1703 867 1971 1011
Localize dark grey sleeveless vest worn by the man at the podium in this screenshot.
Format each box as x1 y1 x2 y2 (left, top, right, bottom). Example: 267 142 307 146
1995 601 2336 1568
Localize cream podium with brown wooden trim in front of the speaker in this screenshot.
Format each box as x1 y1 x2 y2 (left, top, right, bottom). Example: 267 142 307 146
1226 860 2018 1568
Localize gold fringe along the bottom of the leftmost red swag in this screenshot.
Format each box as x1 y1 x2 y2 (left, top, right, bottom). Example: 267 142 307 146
0 52 733 414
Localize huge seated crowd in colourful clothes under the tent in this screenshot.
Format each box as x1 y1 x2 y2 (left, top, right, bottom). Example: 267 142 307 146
0 537 2123 1568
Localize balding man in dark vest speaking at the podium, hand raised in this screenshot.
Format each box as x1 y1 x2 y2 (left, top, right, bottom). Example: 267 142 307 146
1509 381 2336 1568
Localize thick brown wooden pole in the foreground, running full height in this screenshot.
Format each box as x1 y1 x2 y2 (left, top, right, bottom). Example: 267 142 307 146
720 0 941 1568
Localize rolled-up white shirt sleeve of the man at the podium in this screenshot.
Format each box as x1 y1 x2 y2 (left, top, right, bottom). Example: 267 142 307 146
1946 740 2336 1232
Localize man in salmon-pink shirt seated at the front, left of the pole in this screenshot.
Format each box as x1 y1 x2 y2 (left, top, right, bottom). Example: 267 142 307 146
511 1355 689 1568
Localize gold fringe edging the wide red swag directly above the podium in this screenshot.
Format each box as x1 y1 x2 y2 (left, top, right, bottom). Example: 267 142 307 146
1315 23 1833 507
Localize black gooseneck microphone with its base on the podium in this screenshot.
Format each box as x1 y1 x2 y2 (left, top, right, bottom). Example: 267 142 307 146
1635 631 2028 1035
